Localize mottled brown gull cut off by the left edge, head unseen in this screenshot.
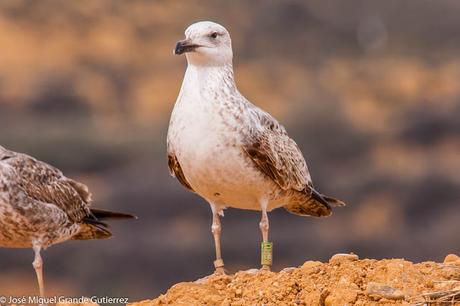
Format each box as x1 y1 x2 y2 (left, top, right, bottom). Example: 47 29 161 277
0 146 135 298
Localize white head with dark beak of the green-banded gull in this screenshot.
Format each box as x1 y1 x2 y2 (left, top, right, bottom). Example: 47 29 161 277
174 21 233 66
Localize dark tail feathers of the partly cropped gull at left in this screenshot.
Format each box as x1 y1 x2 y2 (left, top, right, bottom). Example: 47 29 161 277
72 209 137 240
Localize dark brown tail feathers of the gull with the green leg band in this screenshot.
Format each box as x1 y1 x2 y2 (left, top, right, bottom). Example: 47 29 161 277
284 188 345 217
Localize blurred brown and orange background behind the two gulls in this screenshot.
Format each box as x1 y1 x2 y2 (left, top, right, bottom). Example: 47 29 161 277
0 0 460 300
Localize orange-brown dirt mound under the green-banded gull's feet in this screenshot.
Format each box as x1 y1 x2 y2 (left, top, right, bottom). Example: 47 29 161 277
131 254 460 306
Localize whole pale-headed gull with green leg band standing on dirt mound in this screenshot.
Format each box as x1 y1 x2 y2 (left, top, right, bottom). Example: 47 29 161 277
167 21 345 273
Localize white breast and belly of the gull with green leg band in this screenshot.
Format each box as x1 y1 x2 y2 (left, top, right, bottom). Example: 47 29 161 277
169 72 276 210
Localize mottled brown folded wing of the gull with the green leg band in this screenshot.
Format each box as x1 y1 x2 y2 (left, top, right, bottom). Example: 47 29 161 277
243 111 312 191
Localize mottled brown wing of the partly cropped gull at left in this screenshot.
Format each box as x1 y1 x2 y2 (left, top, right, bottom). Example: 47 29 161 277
6 153 91 222
